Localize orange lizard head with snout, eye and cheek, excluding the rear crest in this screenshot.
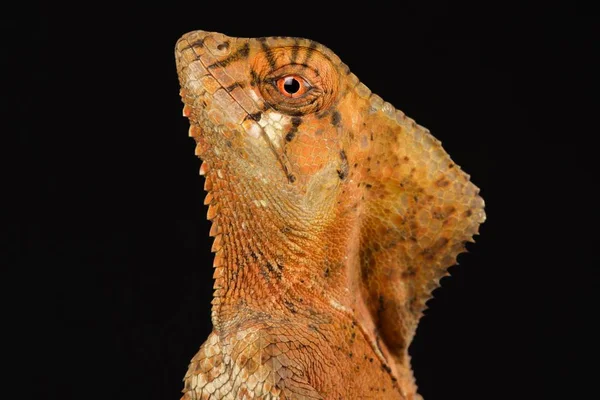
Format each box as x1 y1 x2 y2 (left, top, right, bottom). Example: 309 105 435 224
176 31 356 197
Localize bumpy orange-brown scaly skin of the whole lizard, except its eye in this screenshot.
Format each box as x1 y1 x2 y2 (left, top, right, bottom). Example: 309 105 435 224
175 31 485 400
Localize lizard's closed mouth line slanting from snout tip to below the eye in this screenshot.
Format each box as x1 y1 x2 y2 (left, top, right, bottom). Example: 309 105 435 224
177 38 296 183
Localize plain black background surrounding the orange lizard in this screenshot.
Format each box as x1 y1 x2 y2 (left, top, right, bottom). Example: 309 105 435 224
1 2 600 400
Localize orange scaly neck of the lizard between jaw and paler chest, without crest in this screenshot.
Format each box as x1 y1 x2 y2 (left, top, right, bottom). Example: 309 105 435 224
202 145 350 330
